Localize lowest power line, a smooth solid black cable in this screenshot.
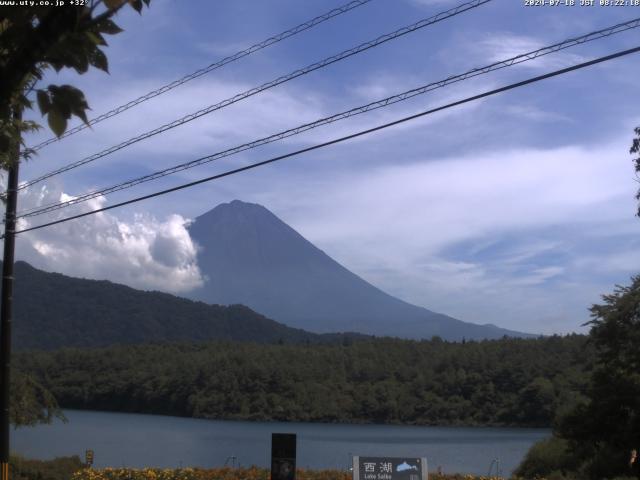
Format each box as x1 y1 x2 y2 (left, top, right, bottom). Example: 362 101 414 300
15 46 640 234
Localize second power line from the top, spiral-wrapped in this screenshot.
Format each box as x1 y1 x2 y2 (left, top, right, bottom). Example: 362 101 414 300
19 0 492 190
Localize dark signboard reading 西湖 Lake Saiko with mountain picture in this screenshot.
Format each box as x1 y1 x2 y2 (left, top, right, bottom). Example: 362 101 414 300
353 456 429 480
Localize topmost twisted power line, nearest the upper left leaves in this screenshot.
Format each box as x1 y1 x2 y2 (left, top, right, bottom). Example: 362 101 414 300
30 0 371 151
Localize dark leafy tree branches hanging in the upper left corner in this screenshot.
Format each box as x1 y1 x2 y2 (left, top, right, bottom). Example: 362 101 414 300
0 0 150 168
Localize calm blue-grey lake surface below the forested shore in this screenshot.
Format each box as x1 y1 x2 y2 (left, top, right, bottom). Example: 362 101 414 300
11 410 551 475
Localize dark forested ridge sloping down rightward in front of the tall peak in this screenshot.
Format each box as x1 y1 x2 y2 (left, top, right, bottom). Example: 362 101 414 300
6 262 350 349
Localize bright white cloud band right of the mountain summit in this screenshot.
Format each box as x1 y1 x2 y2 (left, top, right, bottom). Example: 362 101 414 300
294 142 635 253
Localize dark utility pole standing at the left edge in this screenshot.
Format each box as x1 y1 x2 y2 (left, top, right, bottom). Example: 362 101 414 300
0 107 22 480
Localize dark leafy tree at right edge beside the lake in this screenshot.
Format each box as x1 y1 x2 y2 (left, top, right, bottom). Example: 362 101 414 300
558 276 640 478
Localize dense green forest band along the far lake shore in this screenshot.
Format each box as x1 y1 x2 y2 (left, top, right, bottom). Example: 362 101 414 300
15 335 593 427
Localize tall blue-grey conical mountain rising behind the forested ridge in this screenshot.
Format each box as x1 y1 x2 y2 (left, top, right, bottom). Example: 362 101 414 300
187 200 526 340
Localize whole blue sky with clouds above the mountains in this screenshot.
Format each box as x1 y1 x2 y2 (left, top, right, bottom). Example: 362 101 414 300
12 0 640 333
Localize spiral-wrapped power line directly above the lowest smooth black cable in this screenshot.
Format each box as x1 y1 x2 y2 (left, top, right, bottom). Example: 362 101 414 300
18 17 640 218
